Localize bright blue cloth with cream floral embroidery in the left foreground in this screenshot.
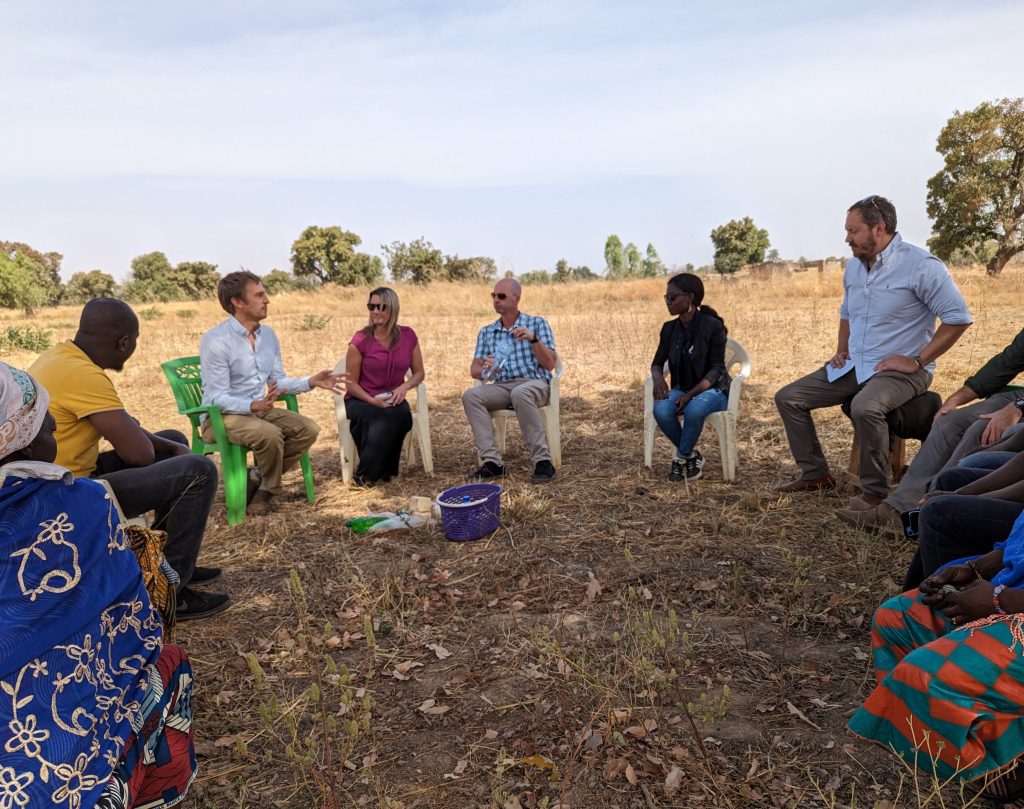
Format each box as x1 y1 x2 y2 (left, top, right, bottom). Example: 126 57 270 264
0 464 161 809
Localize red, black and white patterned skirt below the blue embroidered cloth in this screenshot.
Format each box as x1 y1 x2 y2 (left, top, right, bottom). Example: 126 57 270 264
96 644 197 809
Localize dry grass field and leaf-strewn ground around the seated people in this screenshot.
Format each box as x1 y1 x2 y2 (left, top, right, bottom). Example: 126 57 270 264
8 268 1024 809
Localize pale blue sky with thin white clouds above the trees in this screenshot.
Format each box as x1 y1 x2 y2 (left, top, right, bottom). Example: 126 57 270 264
0 0 1024 278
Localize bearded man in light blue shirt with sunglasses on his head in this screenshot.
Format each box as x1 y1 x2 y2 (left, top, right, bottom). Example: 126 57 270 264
775 196 971 510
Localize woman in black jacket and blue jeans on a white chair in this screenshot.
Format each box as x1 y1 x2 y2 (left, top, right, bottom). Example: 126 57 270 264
650 272 730 481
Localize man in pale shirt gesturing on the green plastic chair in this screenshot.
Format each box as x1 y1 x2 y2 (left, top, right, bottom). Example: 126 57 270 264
200 270 342 514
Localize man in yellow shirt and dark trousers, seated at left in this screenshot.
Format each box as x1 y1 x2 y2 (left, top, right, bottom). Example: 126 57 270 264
29 298 230 621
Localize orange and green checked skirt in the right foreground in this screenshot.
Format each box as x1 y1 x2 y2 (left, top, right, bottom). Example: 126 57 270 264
849 590 1024 780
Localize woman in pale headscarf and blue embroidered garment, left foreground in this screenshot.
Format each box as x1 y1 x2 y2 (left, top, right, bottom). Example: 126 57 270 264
0 363 196 809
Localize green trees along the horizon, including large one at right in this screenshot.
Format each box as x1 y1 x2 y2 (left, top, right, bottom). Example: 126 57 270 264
0 98 1024 313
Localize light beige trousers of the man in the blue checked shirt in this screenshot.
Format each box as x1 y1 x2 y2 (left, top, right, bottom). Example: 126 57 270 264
462 378 551 466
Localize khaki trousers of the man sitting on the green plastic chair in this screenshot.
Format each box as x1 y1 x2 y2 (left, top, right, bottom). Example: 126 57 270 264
203 408 319 495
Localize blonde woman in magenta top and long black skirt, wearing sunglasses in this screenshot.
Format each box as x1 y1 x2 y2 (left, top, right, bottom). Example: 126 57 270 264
345 287 423 483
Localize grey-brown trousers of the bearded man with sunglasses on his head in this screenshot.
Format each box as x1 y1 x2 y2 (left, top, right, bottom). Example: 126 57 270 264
775 368 932 497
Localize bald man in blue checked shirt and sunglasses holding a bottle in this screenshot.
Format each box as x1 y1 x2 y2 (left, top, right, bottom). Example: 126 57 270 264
462 279 558 483
